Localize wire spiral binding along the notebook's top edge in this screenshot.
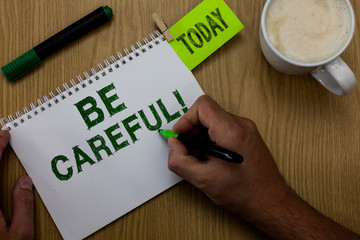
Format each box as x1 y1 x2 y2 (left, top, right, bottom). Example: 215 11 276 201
0 30 165 131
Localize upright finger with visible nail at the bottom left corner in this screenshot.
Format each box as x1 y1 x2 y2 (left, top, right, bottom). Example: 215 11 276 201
10 176 34 239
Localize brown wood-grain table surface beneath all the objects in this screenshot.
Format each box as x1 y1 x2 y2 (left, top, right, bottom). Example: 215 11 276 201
0 0 360 240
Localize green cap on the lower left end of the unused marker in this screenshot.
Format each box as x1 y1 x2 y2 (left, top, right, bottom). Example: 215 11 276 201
1 49 41 82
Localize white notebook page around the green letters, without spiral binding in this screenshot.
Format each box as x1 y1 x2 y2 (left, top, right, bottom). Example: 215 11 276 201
5 40 203 240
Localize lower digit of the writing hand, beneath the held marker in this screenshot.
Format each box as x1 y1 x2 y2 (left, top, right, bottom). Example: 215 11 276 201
168 137 207 184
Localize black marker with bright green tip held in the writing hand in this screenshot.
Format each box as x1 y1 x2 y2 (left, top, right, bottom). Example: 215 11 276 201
159 129 244 163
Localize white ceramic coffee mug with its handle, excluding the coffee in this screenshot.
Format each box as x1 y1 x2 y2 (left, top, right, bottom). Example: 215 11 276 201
260 0 356 96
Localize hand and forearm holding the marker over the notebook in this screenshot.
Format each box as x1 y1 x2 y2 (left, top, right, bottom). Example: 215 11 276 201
168 96 360 240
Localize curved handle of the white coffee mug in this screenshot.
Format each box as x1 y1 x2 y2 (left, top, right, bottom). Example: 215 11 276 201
311 57 356 96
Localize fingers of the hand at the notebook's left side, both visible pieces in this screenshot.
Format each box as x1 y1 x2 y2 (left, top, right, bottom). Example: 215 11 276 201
0 131 34 240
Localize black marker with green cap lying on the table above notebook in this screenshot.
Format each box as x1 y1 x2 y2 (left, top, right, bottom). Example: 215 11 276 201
1 6 113 82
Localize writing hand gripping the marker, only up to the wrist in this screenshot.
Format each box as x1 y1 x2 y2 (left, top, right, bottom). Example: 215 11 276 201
168 96 290 221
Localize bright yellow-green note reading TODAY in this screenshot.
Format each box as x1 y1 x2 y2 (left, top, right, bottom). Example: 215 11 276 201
169 0 244 70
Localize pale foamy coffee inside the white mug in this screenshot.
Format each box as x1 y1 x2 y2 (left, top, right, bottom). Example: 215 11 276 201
266 0 351 63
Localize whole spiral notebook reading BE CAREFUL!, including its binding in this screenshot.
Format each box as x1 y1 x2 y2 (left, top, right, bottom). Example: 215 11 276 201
1 33 203 240
